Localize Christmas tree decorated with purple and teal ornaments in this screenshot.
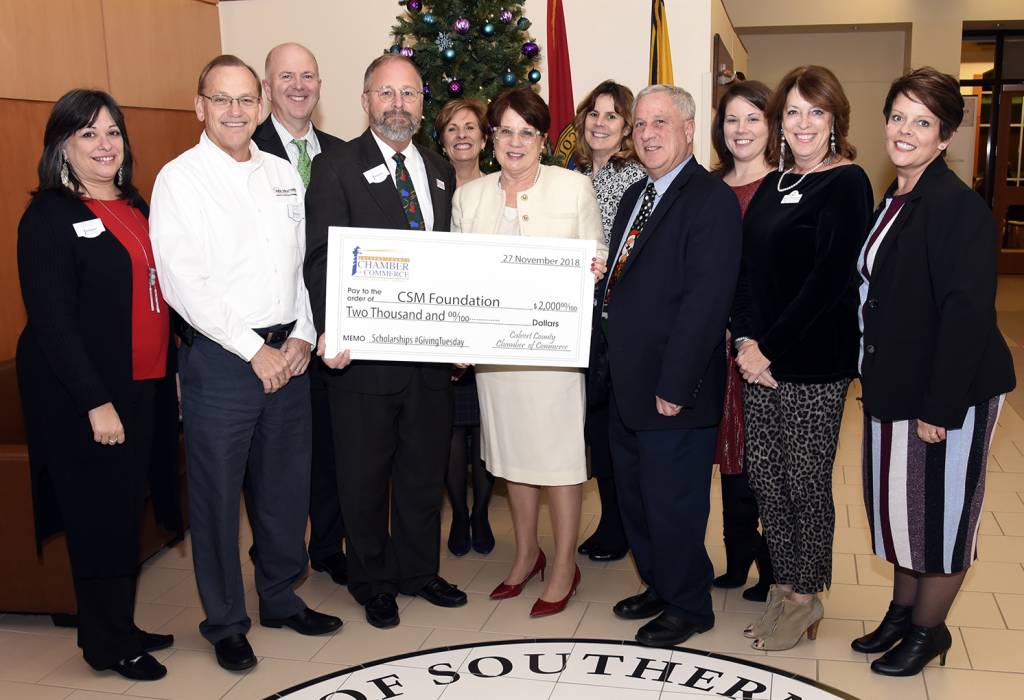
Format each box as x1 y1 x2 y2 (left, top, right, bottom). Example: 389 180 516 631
388 0 541 155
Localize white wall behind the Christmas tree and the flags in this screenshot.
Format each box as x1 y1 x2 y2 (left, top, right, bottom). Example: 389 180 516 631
218 0 746 163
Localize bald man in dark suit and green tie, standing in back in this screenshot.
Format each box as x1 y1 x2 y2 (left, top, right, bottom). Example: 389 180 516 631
249 44 347 585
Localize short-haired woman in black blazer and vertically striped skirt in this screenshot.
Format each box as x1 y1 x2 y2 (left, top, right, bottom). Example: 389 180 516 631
852 68 1015 675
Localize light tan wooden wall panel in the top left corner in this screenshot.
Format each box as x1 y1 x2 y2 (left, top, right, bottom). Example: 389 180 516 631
0 0 109 100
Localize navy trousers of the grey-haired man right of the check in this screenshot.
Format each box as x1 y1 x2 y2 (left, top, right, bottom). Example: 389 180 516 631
608 395 718 625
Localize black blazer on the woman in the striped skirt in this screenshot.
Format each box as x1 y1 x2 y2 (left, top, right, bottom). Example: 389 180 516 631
861 158 1016 429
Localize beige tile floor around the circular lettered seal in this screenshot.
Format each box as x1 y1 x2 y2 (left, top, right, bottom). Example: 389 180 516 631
6 277 1024 700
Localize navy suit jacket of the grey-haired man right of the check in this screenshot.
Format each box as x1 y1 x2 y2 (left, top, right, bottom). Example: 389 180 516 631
595 160 741 430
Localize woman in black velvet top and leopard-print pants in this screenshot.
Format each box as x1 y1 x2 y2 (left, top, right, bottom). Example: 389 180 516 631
732 65 871 651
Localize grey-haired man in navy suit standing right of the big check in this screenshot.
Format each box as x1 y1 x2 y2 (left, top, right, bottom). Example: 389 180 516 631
595 85 740 647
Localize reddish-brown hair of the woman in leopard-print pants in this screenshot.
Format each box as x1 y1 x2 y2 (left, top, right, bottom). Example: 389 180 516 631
767 65 857 165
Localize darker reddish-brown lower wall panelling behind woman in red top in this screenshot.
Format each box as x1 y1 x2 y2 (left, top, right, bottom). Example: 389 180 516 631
0 99 202 360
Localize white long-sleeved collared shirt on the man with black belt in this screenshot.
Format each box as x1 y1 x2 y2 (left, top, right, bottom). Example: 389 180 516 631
150 132 316 361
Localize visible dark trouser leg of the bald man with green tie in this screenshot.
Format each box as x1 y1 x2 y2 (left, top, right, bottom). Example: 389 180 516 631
308 357 345 562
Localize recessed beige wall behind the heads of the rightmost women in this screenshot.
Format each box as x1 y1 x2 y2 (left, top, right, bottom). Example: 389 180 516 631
743 32 905 200
